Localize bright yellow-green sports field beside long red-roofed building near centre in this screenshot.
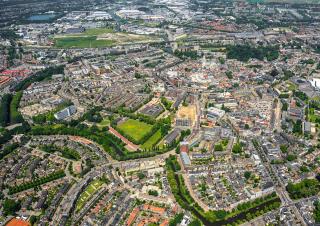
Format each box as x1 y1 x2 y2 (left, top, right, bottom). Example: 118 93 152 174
118 119 152 141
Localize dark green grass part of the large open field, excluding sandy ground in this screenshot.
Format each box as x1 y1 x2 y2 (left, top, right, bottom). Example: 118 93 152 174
54 36 115 48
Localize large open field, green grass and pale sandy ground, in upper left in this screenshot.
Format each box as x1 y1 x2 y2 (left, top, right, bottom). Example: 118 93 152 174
53 28 159 48
